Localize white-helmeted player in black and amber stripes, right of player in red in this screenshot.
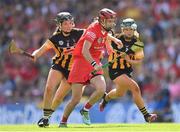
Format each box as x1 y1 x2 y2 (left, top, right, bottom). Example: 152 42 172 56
100 18 157 122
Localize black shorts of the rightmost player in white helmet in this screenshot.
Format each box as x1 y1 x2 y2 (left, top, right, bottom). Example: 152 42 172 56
109 68 133 80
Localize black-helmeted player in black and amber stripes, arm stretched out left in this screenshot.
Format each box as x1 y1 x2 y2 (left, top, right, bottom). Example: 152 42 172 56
32 12 84 127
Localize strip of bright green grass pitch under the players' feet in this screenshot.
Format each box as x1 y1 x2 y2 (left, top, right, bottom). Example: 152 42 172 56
0 123 180 132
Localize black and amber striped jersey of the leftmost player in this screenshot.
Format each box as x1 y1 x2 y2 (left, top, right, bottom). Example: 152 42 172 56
49 28 84 74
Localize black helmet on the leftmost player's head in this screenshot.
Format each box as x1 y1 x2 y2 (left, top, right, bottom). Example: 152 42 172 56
55 12 74 24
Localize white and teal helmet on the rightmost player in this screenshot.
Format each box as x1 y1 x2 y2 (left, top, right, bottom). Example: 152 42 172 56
121 18 137 30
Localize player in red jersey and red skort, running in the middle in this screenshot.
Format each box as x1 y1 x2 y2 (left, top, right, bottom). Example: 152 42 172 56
60 8 122 127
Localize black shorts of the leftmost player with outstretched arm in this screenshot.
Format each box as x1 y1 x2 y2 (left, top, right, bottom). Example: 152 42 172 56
51 64 70 79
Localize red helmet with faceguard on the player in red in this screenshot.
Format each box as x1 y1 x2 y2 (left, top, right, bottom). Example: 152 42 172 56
98 8 116 31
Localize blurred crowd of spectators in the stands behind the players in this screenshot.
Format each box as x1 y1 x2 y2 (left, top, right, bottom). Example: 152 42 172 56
0 0 180 121
